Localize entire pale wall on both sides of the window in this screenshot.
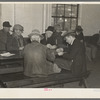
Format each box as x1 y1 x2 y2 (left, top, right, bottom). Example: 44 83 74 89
0 4 100 36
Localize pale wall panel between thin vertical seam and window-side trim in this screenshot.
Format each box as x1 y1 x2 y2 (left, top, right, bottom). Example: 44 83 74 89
15 4 43 36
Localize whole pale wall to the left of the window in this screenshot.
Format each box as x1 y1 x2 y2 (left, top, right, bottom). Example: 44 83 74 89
0 4 51 37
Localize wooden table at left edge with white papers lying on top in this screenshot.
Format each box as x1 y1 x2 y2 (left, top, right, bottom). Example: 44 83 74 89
0 51 23 74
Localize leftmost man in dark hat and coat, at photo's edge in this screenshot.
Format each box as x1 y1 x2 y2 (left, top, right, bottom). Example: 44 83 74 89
0 21 11 51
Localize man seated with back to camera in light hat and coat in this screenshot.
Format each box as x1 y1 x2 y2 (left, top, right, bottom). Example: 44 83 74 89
24 29 60 77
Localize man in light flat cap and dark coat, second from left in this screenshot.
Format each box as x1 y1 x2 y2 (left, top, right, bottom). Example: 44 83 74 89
7 24 25 51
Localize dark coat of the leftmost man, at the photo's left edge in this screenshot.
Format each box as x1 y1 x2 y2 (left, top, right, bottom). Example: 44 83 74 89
0 29 10 51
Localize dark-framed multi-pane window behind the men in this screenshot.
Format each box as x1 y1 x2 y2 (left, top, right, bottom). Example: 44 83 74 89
52 4 79 30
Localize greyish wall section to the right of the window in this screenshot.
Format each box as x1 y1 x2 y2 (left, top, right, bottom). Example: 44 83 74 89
79 4 100 35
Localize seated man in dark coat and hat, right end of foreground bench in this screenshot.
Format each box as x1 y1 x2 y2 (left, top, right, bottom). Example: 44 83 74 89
55 32 86 75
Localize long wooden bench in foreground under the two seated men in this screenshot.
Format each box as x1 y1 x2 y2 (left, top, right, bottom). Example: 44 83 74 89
0 71 90 88
